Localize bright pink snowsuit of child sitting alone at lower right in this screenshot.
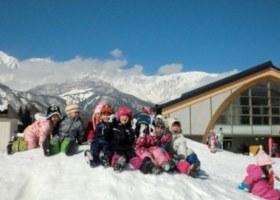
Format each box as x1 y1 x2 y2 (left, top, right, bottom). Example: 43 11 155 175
243 164 280 200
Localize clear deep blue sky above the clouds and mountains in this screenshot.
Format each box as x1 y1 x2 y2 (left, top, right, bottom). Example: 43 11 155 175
0 0 280 74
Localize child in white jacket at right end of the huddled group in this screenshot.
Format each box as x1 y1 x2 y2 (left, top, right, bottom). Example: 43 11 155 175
169 119 200 177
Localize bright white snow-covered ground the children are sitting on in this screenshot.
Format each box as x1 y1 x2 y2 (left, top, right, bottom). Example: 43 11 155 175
0 140 280 200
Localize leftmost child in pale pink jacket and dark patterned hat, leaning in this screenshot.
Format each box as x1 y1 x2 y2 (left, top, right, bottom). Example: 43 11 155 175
23 105 61 149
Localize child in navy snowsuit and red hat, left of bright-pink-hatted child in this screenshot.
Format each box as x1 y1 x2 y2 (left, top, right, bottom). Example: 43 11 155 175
84 104 114 167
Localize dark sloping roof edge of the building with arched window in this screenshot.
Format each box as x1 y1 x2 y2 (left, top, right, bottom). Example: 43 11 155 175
157 61 280 109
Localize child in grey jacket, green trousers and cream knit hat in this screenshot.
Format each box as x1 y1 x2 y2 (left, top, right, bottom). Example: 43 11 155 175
55 103 84 155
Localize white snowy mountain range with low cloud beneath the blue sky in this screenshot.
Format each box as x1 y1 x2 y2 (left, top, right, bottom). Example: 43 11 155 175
0 52 237 103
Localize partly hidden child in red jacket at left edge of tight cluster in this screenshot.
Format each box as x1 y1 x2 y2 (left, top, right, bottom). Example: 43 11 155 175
85 102 105 144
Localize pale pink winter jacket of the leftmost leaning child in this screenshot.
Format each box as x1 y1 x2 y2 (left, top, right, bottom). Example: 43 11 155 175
23 119 52 149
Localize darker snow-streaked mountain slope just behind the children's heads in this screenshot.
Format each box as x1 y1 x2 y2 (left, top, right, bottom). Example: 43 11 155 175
29 80 153 116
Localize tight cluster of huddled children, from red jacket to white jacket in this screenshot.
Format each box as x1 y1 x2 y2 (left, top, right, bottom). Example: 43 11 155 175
84 103 200 176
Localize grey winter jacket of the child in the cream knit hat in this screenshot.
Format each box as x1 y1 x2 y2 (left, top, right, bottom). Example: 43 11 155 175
58 117 85 143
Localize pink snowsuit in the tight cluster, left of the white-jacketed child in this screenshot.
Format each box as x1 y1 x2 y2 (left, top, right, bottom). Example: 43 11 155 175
135 134 170 166
